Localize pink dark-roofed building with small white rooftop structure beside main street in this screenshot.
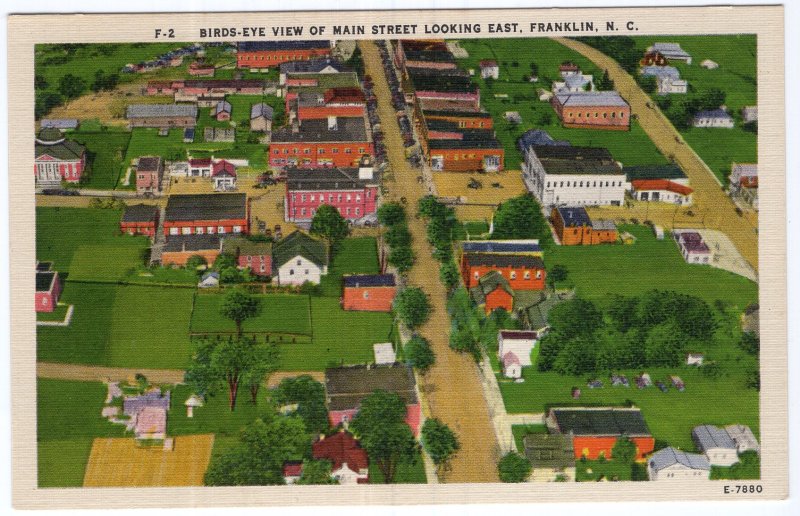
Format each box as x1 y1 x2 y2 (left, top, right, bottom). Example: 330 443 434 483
284 160 380 222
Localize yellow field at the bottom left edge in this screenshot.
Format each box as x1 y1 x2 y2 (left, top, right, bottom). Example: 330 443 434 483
83 434 214 487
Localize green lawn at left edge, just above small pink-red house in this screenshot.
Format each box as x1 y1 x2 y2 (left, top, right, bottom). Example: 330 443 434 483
36 207 150 280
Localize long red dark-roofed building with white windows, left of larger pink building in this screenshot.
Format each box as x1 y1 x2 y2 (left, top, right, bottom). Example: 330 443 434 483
164 193 249 236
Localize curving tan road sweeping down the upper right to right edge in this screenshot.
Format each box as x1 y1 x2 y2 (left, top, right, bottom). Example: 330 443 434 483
554 38 758 271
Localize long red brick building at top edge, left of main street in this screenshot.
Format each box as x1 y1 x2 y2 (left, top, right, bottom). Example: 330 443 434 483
236 40 331 70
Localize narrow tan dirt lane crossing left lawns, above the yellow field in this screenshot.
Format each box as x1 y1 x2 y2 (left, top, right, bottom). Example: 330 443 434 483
36 362 325 387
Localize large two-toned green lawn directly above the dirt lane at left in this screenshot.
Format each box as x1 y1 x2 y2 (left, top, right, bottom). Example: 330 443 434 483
37 282 193 369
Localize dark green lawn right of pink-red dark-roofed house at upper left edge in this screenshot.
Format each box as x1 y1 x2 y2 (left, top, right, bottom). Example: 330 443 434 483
70 131 131 190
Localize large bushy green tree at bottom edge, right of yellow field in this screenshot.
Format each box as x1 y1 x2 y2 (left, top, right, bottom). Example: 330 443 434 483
205 415 310 486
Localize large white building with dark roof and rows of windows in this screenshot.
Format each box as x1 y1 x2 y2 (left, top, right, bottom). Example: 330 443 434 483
522 145 630 207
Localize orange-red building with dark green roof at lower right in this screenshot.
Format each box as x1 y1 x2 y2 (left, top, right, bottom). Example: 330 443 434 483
545 407 655 460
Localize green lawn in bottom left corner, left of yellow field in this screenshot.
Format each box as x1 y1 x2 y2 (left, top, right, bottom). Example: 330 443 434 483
36 379 124 487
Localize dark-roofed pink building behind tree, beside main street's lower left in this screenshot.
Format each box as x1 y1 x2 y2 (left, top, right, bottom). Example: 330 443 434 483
325 364 421 436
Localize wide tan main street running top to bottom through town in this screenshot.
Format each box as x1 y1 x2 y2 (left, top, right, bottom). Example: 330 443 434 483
359 41 499 483
